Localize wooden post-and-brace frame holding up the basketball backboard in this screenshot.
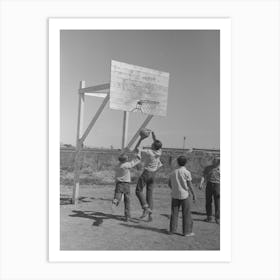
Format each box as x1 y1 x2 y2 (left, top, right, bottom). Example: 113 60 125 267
72 81 153 205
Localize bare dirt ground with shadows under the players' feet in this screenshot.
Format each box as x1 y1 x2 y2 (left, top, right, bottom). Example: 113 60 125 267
60 185 220 250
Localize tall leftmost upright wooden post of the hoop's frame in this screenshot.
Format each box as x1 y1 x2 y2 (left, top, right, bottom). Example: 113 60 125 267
72 81 85 205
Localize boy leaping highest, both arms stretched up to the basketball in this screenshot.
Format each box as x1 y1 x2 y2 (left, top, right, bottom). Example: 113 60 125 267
134 131 162 221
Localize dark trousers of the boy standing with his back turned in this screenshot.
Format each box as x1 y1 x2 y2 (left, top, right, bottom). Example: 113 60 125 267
170 197 193 234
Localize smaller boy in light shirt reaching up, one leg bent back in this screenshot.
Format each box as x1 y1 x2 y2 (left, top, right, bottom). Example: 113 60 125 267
112 153 141 222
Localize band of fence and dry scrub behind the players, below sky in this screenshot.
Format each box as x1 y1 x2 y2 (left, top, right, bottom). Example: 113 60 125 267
60 148 220 184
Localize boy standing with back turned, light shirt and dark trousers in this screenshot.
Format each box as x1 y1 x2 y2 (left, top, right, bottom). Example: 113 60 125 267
168 156 196 236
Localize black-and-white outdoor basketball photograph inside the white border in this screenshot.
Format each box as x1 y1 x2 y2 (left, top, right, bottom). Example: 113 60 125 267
50 18 230 258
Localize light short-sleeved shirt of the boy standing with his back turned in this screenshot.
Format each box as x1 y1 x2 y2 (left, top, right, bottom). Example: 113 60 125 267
169 166 192 199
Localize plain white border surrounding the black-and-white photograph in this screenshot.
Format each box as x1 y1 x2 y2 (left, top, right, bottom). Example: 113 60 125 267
49 18 231 262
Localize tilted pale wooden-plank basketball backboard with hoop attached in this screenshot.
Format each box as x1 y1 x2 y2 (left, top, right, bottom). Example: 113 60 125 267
110 60 169 116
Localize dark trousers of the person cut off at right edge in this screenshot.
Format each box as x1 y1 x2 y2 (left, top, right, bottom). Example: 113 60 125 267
205 182 220 219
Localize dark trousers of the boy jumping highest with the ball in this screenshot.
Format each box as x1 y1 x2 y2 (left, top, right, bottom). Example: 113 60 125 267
135 170 155 209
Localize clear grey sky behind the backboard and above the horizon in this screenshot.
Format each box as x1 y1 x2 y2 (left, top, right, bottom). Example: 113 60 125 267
60 30 220 149
